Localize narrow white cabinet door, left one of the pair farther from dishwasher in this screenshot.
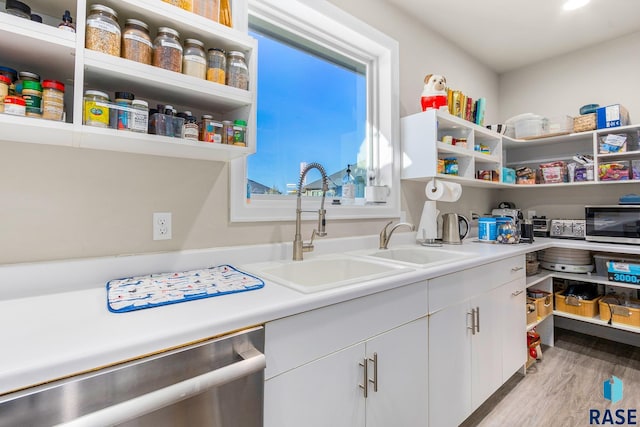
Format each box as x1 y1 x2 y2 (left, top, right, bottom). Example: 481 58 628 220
429 302 471 427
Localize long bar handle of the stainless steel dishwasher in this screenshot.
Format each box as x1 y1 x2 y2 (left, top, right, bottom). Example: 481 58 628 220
55 349 266 427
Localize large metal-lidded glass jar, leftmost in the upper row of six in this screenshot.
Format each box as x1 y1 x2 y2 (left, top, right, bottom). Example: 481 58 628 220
85 4 121 56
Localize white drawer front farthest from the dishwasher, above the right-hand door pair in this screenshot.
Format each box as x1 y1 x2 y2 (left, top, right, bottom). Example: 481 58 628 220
429 255 525 314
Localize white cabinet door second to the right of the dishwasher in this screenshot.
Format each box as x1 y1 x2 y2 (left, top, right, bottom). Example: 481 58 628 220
366 317 429 427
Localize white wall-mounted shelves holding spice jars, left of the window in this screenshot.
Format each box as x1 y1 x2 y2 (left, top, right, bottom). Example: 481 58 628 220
0 0 257 161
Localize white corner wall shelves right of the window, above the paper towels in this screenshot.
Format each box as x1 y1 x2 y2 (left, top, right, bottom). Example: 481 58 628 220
401 110 640 188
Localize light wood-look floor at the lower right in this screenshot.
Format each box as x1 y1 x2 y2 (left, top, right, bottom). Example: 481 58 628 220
461 328 640 427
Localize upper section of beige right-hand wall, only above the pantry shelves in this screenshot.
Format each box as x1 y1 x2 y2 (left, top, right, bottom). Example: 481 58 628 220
499 32 640 122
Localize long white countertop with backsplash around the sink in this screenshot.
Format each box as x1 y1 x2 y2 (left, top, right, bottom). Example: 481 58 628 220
0 233 640 395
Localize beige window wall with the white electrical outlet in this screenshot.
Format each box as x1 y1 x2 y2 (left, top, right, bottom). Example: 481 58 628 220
0 0 498 265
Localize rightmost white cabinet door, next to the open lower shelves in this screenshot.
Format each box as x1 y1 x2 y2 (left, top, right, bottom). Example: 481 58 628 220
469 287 504 411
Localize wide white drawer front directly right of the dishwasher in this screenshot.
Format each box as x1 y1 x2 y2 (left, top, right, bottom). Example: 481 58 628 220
265 282 427 379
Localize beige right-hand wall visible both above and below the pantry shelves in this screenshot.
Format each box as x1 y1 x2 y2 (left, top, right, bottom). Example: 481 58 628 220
496 32 640 218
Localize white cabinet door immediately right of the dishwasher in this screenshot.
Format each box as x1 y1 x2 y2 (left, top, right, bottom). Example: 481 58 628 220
264 344 365 427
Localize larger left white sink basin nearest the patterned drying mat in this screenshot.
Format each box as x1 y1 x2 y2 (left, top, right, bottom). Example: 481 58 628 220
243 256 411 293
